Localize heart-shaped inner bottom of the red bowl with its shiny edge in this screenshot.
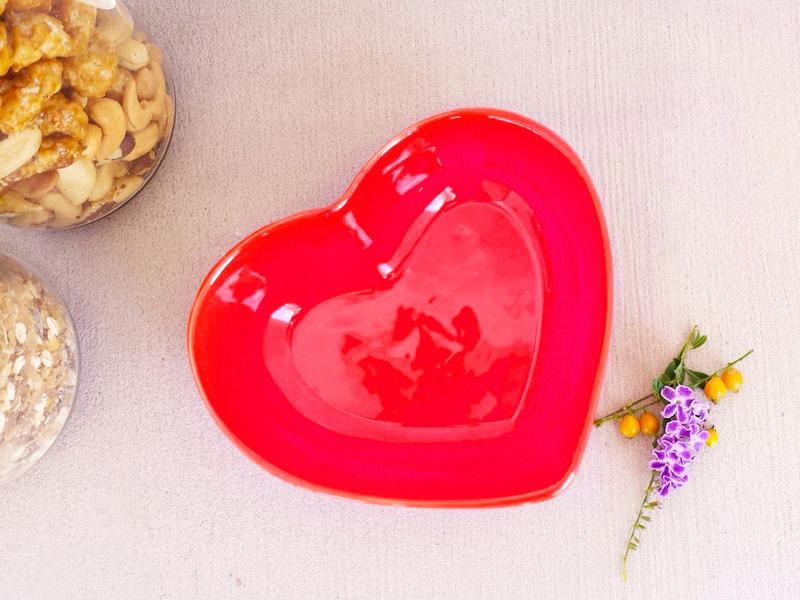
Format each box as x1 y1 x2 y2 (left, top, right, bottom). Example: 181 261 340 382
265 196 543 442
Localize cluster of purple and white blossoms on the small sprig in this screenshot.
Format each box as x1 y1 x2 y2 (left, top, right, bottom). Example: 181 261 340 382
650 385 709 498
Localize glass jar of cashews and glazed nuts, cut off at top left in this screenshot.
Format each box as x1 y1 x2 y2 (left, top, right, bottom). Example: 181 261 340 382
0 0 175 229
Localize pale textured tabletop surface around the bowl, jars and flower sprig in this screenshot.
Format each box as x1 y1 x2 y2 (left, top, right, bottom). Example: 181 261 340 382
0 0 800 600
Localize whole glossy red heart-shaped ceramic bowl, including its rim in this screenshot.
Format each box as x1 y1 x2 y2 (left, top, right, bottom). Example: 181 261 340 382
189 109 611 506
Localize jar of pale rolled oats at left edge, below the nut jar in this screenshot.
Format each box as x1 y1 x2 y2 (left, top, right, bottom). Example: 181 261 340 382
0 254 78 483
